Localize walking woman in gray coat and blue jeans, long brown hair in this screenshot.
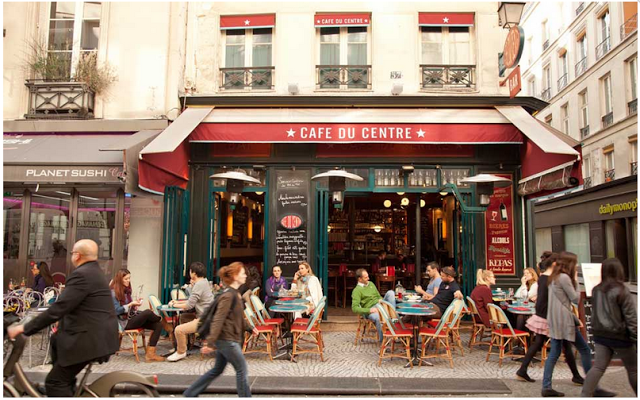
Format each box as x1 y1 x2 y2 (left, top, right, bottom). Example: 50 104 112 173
542 251 609 397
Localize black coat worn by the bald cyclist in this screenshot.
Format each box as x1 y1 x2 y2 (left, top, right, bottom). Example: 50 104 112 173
24 261 119 367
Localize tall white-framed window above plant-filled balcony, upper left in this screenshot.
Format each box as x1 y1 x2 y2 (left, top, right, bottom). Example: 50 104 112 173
47 2 102 79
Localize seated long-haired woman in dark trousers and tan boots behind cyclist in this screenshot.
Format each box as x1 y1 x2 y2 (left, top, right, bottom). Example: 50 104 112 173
109 268 164 362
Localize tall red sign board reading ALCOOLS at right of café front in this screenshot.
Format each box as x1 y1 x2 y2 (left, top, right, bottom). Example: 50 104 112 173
485 174 516 275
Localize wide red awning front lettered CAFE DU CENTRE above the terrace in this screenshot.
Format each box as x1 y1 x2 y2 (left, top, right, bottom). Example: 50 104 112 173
189 123 523 144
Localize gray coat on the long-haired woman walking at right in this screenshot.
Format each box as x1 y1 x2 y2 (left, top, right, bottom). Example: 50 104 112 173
547 274 579 342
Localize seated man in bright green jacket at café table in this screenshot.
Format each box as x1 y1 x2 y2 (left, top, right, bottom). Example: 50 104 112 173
351 268 396 342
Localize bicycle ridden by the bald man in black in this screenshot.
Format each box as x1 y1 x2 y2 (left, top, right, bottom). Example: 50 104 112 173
2 315 160 397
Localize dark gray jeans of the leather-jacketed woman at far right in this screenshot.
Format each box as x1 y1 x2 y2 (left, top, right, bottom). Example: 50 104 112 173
582 343 638 397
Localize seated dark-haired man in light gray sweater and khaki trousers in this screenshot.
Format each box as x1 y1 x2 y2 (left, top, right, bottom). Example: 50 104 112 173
167 262 213 361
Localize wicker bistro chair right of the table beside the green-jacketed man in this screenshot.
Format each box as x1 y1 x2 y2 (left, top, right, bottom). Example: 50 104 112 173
419 300 463 368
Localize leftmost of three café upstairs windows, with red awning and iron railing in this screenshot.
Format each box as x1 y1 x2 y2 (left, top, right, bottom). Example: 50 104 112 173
220 14 275 90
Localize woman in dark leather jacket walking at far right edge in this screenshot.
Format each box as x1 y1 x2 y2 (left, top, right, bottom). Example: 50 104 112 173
582 258 638 397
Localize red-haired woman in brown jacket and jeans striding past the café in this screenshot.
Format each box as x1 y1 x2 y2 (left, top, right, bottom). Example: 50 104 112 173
183 262 258 397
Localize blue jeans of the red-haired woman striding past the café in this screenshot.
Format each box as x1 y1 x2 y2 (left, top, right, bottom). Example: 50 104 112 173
183 340 251 397
